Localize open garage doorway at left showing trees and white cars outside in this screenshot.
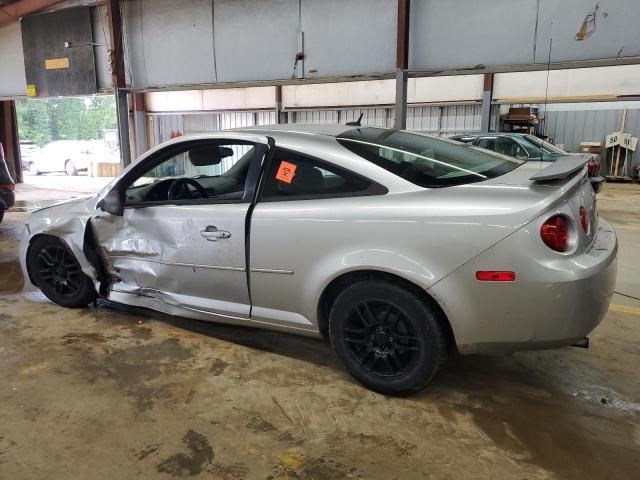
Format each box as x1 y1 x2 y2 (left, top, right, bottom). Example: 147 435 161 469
16 95 120 197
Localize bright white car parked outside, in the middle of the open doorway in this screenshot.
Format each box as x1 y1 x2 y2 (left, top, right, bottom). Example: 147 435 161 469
29 140 111 175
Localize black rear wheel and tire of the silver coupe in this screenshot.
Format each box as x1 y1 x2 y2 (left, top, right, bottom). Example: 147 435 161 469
329 280 448 395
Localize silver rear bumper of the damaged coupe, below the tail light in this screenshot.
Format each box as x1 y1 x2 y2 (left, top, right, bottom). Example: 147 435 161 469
430 219 618 353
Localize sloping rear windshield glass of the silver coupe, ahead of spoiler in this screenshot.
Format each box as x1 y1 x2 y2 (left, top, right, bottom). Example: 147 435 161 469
337 128 522 188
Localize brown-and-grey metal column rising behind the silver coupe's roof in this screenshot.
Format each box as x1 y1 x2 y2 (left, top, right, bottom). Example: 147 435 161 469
394 0 411 129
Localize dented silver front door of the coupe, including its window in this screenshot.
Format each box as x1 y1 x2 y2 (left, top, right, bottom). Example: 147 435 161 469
92 136 267 318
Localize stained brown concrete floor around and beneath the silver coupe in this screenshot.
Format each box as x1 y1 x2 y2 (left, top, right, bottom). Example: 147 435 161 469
0 185 640 480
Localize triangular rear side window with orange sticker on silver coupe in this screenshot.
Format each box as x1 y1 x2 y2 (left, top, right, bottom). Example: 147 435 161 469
262 149 386 200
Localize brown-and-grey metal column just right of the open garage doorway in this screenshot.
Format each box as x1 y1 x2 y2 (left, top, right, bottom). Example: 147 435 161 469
107 0 131 168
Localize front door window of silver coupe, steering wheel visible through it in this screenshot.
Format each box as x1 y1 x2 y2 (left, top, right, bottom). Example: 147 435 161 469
124 141 263 206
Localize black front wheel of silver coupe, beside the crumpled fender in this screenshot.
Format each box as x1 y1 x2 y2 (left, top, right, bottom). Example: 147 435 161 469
27 236 96 308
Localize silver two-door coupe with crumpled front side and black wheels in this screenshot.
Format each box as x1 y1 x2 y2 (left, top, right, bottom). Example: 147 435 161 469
21 125 617 394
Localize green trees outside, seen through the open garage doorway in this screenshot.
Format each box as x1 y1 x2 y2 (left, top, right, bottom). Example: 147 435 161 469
16 96 118 147
